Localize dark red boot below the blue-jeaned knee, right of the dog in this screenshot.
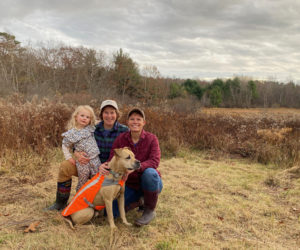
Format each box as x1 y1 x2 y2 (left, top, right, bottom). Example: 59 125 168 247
135 191 158 226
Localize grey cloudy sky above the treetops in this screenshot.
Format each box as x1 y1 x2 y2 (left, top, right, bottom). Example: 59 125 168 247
0 0 300 84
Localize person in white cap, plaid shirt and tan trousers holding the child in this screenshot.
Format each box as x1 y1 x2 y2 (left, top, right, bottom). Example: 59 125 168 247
46 100 128 210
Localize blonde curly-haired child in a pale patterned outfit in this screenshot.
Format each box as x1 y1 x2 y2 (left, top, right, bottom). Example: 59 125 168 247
62 105 101 191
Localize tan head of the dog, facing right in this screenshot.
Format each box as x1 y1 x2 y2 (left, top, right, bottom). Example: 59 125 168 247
114 147 141 172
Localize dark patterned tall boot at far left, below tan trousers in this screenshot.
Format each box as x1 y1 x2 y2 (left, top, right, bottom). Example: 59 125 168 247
45 179 72 211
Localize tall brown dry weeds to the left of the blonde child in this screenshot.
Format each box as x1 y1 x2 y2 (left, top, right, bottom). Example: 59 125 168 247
0 95 72 153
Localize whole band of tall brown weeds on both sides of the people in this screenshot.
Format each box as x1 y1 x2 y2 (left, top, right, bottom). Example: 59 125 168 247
0 96 300 168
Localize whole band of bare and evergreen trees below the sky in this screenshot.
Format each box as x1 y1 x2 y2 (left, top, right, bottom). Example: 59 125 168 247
0 32 300 108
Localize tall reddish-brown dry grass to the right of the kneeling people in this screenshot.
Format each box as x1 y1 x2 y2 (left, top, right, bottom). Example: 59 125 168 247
141 105 300 168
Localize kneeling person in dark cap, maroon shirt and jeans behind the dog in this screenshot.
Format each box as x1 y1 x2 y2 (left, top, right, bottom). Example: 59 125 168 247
109 108 163 226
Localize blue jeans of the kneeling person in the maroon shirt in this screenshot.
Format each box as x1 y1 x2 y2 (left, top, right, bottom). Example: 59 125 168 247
113 168 163 217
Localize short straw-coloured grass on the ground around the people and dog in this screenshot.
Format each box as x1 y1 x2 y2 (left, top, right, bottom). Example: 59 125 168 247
0 150 300 249
